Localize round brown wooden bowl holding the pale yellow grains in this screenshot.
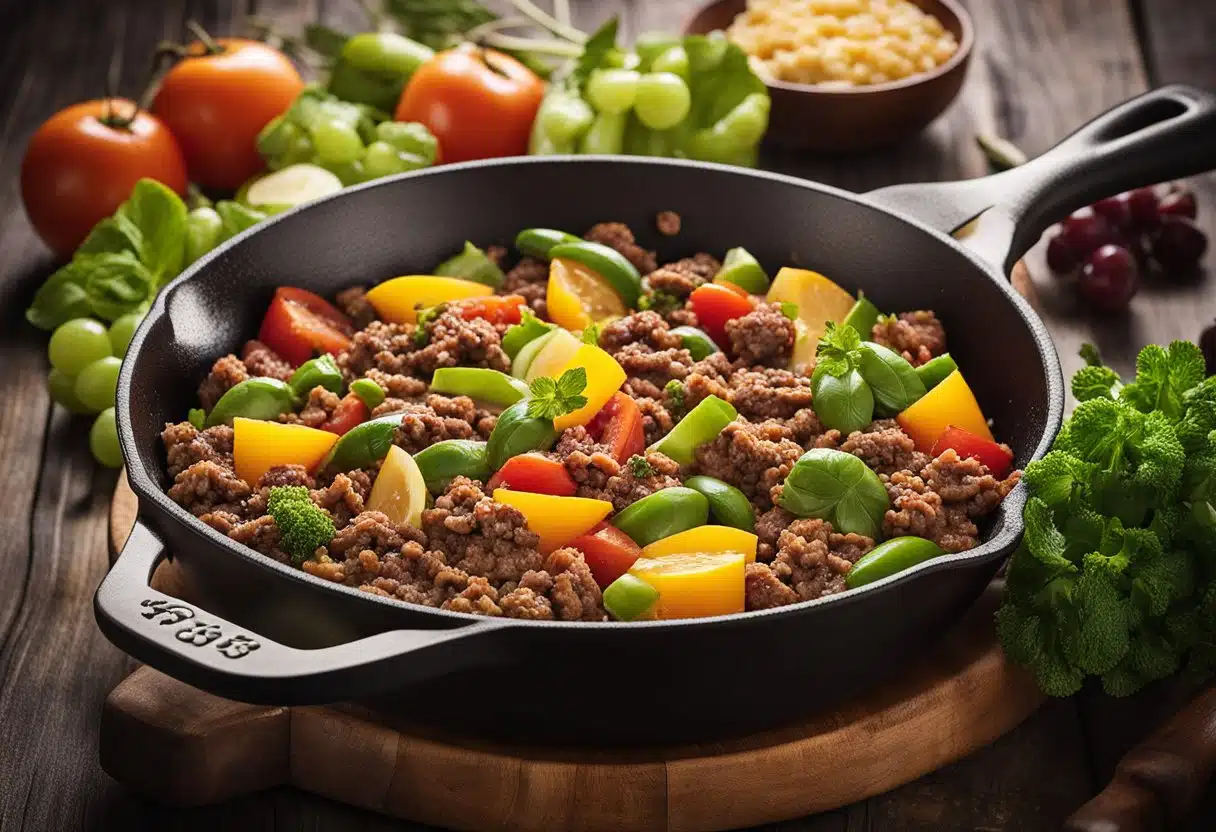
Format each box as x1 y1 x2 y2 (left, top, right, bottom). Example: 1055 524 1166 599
685 0 975 152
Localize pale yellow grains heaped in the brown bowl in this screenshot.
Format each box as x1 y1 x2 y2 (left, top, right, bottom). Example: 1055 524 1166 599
726 0 958 89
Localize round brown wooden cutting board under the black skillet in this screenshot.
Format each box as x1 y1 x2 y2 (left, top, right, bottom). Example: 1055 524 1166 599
100 464 1042 832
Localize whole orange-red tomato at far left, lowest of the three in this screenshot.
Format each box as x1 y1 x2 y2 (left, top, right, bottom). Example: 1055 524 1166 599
21 99 186 258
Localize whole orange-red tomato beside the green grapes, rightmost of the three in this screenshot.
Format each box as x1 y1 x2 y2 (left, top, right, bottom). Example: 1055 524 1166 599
394 44 545 162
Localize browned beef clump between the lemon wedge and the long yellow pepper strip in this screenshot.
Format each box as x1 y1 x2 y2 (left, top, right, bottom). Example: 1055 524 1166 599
422 477 541 585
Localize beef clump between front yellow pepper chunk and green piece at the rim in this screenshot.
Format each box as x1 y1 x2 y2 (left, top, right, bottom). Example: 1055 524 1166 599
744 519 874 609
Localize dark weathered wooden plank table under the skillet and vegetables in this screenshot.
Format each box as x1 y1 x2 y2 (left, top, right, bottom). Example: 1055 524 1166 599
0 0 1216 832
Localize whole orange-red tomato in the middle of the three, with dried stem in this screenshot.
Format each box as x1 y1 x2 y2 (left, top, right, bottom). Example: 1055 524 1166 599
152 38 304 191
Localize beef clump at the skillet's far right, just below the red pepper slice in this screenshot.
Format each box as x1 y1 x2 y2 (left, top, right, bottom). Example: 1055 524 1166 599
882 449 1021 552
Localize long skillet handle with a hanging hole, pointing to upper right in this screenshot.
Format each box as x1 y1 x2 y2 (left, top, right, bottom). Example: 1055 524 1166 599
866 84 1216 274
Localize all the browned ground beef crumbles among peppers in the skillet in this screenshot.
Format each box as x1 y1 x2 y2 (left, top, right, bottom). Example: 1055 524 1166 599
162 218 1020 620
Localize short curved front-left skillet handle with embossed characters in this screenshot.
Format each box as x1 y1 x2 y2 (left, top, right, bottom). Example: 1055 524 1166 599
94 521 508 705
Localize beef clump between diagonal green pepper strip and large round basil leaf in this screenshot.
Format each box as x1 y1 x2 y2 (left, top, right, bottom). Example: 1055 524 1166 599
697 420 803 508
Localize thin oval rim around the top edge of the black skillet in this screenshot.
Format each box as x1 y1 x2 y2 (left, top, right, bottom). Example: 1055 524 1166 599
116 154 1064 634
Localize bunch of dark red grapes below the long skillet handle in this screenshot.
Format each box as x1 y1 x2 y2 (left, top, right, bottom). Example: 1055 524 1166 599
1047 182 1207 311
